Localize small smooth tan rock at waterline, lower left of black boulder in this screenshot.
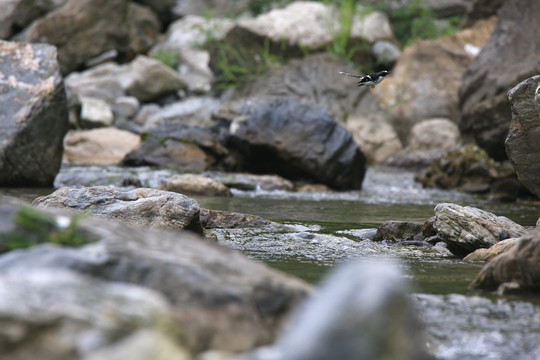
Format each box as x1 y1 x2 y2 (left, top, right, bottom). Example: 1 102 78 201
158 174 232 196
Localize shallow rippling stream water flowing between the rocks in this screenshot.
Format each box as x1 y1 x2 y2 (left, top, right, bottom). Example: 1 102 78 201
0 167 540 360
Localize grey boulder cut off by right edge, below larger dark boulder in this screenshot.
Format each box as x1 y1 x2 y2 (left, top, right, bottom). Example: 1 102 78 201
505 75 540 197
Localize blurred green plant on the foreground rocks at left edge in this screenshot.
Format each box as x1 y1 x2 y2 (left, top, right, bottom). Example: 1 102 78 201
0 205 89 252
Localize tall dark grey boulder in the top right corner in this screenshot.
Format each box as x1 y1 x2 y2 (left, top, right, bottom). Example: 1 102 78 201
459 0 540 160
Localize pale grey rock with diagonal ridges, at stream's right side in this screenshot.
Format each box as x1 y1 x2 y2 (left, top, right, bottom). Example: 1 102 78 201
435 203 526 257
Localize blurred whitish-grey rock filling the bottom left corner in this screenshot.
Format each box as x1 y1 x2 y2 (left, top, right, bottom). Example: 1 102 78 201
0 266 173 360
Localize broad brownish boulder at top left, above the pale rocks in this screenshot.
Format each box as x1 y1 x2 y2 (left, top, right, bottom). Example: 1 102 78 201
15 0 161 74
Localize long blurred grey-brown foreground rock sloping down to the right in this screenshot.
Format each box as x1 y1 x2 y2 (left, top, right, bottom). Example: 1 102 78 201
0 202 311 352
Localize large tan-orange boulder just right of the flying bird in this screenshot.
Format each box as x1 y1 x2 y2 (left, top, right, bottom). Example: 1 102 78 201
373 19 494 144
